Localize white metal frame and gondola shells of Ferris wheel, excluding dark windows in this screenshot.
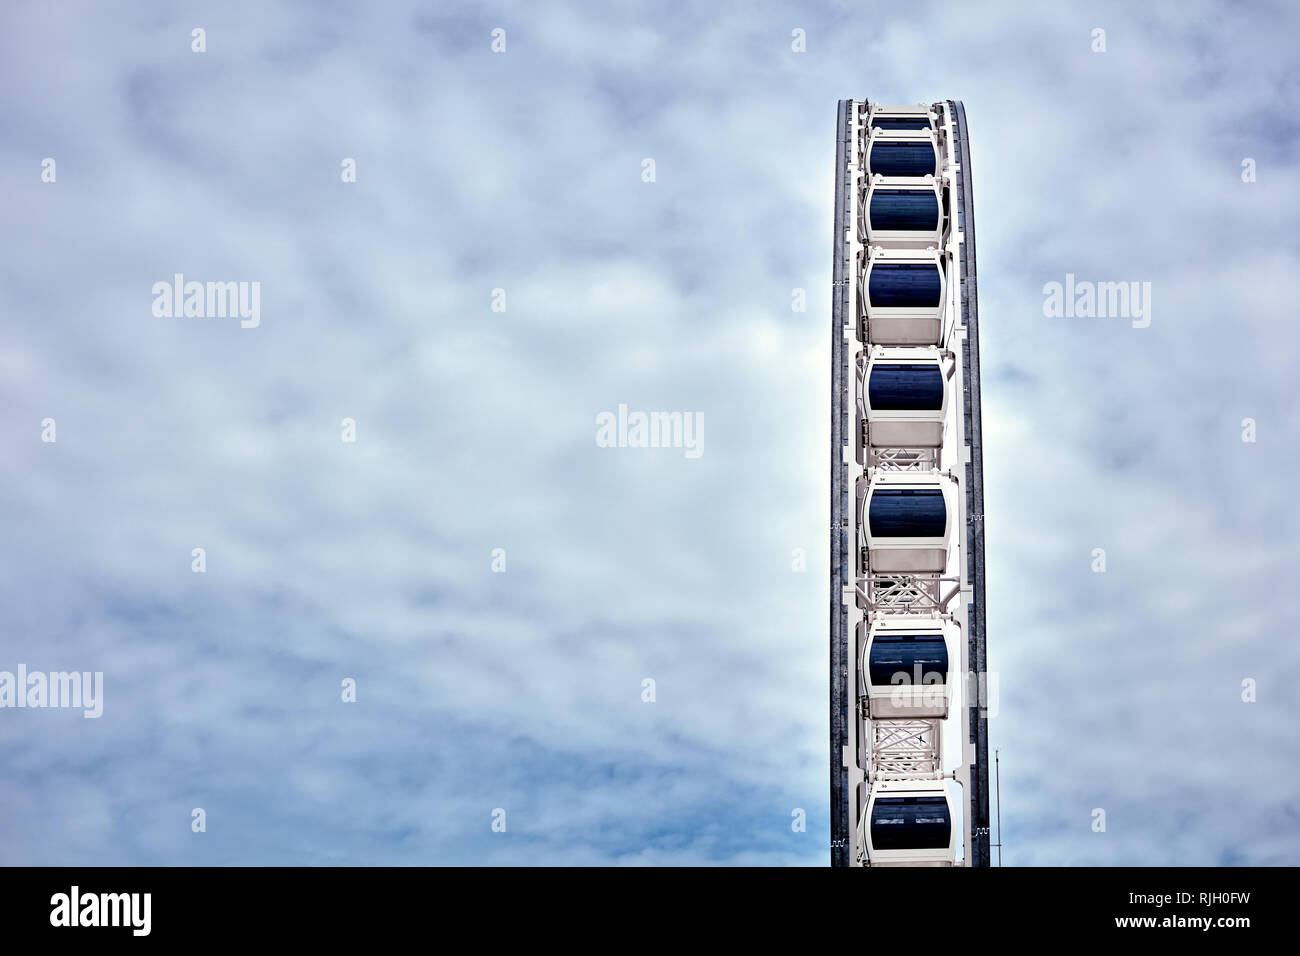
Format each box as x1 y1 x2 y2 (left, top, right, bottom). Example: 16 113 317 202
842 103 971 866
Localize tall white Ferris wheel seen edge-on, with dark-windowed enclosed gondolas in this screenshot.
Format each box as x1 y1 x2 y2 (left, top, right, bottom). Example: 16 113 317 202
831 100 989 866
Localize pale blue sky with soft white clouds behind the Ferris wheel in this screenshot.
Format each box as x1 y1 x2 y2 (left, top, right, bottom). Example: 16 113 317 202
0 3 1300 865
